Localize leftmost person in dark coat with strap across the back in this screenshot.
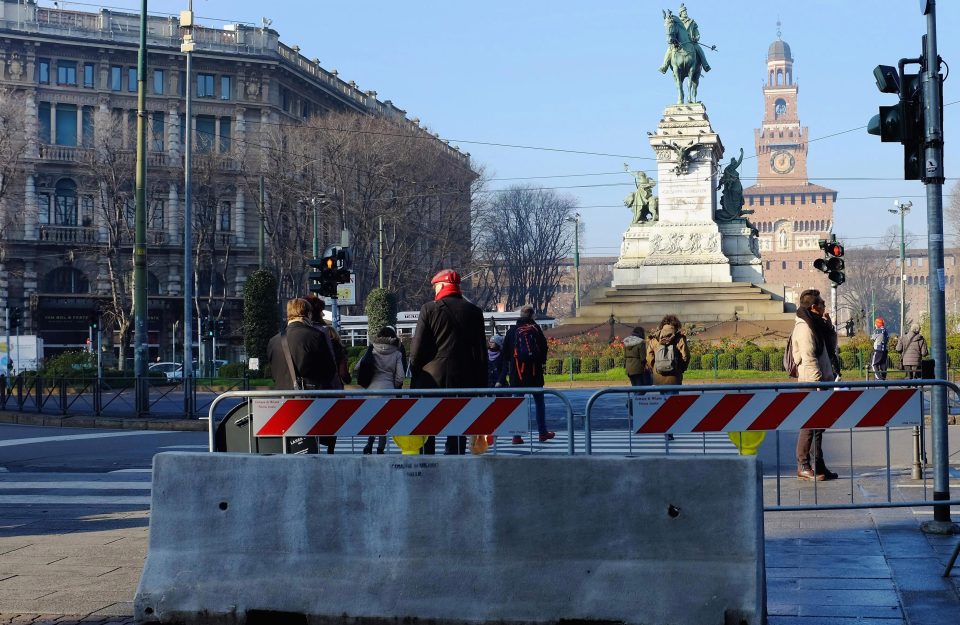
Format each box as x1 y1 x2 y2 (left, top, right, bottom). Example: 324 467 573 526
267 298 337 453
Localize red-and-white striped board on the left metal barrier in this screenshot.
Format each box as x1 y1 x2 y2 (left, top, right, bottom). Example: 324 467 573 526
253 397 529 436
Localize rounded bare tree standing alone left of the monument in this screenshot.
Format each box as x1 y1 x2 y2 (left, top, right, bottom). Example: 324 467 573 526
474 186 576 312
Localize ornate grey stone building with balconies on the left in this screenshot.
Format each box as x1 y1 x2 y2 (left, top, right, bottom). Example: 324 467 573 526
0 0 469 360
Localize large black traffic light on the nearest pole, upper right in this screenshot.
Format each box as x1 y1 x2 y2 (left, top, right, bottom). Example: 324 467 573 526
867 64 926 180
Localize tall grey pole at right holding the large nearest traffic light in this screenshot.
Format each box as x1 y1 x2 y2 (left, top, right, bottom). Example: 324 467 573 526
921 0 955 533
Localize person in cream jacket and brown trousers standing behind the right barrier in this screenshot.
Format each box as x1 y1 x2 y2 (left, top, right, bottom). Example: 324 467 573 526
790 289 837 482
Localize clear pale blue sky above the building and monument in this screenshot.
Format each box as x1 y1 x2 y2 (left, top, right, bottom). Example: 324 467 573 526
47 0 960 256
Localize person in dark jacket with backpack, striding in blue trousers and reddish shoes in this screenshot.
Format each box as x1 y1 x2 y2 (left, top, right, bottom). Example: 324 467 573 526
500 304 556 445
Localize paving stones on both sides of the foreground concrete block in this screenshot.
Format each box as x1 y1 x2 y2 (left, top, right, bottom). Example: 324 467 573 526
0 473 960 625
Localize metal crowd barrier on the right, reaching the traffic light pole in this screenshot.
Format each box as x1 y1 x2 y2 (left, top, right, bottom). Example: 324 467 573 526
584 379 960 512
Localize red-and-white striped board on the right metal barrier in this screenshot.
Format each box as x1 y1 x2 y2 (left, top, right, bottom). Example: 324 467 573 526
633 388 922 434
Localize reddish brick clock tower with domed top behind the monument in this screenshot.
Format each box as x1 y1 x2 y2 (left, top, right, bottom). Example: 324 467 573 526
744 33 837 304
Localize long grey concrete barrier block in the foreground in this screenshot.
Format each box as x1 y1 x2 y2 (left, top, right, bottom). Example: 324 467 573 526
134 452 766 625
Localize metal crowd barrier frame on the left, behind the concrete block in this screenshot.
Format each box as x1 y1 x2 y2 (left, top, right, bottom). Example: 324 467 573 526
208 388 574 455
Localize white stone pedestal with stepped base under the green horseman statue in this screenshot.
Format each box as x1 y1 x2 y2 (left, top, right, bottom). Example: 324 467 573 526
570 103 792 323
